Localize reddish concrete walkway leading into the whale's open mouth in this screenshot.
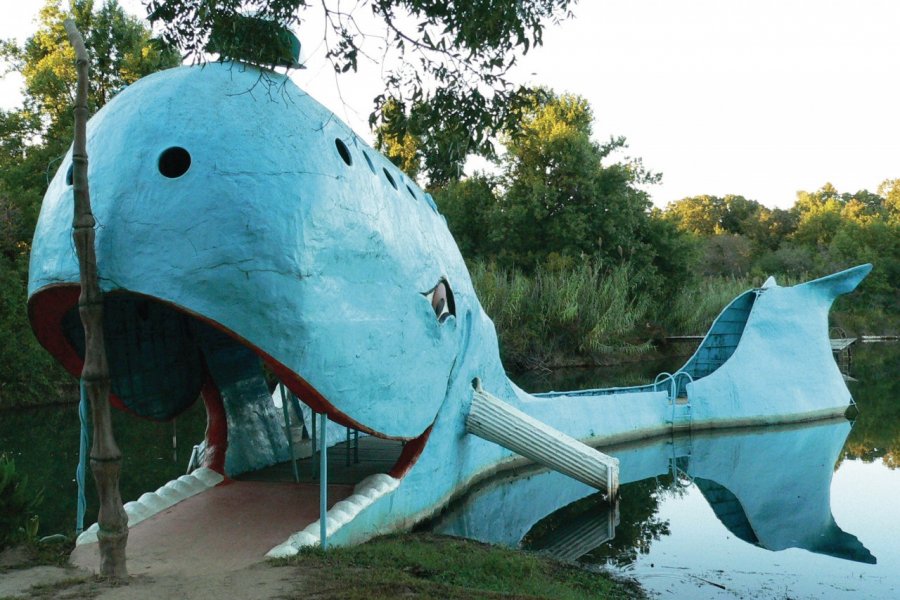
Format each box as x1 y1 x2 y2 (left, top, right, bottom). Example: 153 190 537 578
71 481 353 576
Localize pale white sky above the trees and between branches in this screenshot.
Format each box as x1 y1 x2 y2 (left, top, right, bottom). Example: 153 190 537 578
0 0 900 208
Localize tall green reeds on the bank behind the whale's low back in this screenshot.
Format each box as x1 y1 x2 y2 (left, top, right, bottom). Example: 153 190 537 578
470 261 793 370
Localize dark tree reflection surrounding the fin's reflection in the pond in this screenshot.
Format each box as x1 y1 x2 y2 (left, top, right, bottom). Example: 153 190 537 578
522 475 683 567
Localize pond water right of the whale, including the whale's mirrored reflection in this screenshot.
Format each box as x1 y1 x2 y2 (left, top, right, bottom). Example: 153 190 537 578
432 344 900 599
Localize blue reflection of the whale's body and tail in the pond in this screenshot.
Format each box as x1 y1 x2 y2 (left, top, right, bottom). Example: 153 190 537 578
434 420 876 563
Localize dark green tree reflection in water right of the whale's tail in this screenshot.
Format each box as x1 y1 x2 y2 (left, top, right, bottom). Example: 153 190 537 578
835 344 900 469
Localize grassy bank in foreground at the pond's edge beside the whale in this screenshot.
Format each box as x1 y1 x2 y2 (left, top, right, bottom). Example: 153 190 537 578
288 534 644 600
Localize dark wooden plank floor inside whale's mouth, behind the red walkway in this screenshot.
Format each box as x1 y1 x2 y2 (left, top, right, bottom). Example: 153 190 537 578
237 436 403 485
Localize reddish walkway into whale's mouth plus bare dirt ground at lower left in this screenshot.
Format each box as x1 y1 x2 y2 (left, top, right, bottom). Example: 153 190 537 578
0 481 352 600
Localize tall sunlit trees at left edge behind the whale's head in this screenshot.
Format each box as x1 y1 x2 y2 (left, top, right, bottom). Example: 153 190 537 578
0 0 181 407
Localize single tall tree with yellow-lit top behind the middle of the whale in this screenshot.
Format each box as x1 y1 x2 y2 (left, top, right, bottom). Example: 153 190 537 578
491 94 658 268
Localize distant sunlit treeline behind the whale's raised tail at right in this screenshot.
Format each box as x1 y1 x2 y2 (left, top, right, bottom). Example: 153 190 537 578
662 179 900 314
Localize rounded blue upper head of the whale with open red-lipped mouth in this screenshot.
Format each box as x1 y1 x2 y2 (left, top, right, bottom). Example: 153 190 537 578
29 63 502 468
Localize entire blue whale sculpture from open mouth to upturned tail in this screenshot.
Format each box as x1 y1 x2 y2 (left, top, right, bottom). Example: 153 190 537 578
29 63 871 555
